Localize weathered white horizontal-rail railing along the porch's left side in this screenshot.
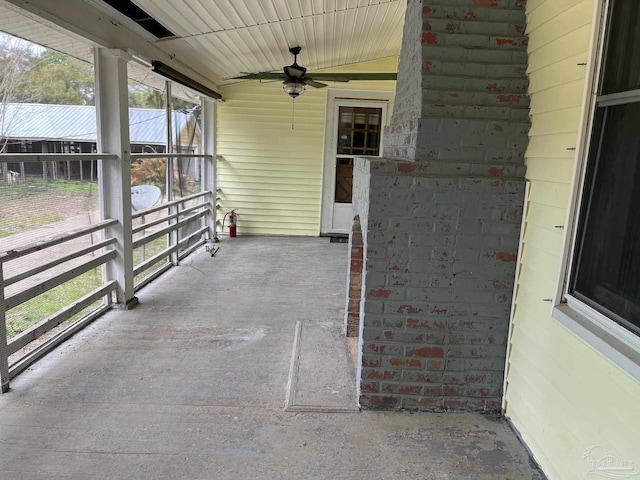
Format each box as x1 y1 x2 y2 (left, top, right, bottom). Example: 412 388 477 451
0 153 216 392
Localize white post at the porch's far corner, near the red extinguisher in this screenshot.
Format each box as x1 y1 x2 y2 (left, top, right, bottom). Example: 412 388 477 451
201 97 218 238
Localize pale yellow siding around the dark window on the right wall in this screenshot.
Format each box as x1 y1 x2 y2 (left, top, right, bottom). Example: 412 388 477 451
506 0 640 480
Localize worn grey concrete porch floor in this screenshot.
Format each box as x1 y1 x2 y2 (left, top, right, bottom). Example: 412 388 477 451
0 237 543 480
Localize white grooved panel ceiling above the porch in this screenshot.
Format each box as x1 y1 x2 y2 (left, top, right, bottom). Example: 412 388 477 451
0 0 407 95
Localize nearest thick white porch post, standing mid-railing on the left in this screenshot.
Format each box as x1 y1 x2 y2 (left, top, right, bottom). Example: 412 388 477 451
94 48 137 308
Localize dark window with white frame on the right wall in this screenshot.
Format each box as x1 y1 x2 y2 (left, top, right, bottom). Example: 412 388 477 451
567 0 640 335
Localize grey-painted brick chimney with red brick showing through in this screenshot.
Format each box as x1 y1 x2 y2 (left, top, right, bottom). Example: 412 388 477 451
353 0 529 411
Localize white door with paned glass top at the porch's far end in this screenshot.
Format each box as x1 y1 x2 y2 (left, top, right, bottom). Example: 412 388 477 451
320 91 393 235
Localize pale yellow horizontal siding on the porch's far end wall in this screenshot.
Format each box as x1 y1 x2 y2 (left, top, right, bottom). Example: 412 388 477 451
216 57 397 235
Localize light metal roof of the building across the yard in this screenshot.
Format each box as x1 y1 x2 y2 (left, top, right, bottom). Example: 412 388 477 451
0 103 193 145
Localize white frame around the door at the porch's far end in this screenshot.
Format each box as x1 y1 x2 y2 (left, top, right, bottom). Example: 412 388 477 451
320 89 395 236
